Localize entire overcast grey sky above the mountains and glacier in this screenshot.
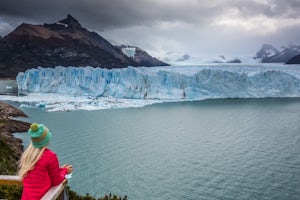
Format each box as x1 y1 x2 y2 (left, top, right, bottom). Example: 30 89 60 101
0 0 300 58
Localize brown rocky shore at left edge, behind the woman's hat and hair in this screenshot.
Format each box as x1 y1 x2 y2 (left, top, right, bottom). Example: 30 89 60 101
0 101 30 175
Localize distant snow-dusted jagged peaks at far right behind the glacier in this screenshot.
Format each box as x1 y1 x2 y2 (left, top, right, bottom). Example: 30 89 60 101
256 43 300 63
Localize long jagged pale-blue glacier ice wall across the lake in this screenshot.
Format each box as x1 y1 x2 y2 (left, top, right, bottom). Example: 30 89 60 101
17 64 300 100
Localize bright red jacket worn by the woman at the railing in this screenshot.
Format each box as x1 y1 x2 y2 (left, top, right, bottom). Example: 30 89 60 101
22 149 67 200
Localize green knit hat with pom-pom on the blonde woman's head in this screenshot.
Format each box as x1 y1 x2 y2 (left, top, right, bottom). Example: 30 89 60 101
28 123 51 148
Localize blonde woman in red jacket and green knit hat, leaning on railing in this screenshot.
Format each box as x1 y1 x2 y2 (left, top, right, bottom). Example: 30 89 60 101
19 123 73 200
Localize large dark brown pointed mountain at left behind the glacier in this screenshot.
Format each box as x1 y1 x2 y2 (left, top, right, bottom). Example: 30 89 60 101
0 15 167 78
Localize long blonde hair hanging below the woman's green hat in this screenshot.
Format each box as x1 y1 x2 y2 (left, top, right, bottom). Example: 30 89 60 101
18 142 46 179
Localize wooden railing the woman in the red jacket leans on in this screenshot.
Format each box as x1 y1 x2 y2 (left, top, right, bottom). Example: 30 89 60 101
0 175 69 200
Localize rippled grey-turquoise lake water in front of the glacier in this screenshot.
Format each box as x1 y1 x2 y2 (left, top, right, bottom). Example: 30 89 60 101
13 98 300 200
